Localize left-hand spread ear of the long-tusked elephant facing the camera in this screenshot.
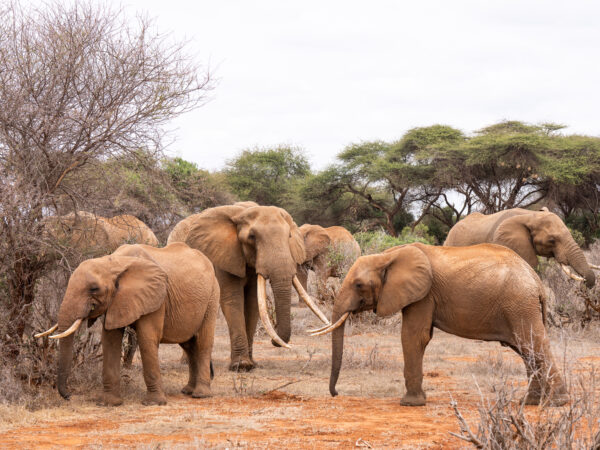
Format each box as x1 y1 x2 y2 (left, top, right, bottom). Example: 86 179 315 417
185 206 246 277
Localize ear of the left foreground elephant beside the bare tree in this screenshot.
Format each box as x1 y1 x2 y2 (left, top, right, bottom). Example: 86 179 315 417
104 256 167 330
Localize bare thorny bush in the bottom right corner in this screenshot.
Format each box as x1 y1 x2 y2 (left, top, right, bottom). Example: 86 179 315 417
450 336 600 450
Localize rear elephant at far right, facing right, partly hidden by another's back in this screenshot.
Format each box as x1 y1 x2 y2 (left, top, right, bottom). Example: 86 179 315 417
444 207 596 288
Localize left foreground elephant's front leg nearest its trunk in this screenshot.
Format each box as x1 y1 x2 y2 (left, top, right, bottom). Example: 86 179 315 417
99 328 123 406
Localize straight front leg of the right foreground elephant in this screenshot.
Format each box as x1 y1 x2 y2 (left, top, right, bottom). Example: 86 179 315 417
400 299 434 406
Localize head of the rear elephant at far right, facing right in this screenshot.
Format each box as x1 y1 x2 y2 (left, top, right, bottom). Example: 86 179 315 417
493 208 596 288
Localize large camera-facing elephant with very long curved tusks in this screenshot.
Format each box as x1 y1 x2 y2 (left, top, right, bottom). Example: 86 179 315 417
168 202 328 371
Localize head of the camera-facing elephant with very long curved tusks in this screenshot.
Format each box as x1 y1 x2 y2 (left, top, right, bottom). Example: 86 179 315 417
185 203 327 345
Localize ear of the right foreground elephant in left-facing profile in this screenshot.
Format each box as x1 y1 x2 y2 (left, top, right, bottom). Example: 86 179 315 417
377 246 433 316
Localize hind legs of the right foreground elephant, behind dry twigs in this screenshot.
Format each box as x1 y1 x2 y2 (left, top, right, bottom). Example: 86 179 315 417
511 321 569 406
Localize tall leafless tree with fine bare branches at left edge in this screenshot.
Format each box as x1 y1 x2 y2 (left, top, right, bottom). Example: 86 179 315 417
0 1 211 355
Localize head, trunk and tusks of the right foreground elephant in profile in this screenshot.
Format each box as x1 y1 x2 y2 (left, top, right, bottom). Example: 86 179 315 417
313 245 433 396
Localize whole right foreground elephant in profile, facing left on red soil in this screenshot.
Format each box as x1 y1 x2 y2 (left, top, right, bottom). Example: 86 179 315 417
311 243 568 406
